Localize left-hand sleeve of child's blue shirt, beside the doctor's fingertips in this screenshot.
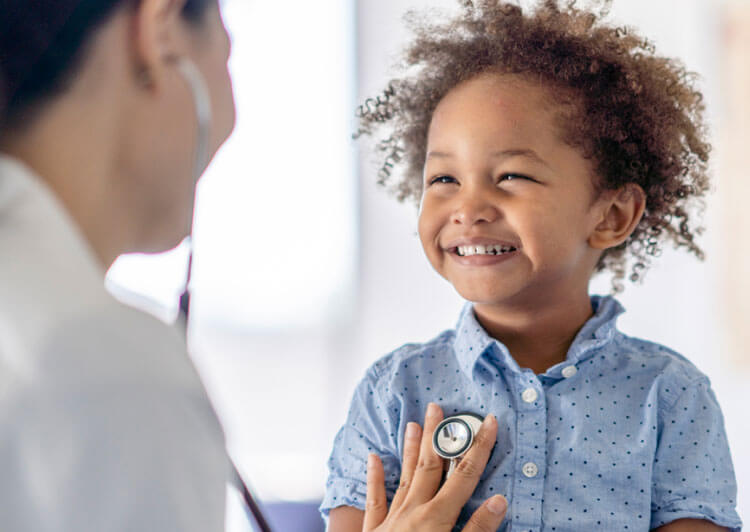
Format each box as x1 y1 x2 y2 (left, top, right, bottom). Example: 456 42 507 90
320 368 401 520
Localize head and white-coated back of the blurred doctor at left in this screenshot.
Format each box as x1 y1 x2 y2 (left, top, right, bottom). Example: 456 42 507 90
0 0 234 532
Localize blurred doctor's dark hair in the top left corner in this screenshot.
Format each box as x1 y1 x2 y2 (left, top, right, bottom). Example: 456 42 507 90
0 0 216 130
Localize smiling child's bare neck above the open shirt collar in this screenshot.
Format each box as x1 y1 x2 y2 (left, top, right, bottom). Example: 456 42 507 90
474 294 593 374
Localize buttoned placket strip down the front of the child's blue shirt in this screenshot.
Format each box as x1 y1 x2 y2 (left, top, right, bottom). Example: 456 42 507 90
511 370 547 532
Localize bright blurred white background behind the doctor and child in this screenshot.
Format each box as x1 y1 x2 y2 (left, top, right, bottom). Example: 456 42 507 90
108 0 750 532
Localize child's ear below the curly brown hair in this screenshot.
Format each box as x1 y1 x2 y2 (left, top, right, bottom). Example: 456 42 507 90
589 183 646 250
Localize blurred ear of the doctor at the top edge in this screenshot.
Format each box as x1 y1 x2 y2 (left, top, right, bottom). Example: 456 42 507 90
132 0 185 90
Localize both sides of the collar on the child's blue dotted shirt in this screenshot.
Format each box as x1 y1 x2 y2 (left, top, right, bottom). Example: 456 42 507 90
453 296 625 378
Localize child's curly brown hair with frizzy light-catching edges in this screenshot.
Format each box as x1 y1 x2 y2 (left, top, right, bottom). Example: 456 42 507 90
354 0 711 292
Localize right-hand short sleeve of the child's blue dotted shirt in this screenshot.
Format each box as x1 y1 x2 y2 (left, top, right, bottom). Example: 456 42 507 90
651 378 742 530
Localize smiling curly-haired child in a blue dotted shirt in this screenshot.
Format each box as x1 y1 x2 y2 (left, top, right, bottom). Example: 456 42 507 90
321 0 741 531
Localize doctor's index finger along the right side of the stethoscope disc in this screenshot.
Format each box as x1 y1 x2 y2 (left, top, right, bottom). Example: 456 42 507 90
435 414 497 515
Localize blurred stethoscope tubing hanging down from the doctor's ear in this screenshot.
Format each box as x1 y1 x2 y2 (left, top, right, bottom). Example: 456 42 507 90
176 58 272 532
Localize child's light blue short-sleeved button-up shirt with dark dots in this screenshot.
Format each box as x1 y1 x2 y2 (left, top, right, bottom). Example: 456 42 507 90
321 296 741 532
